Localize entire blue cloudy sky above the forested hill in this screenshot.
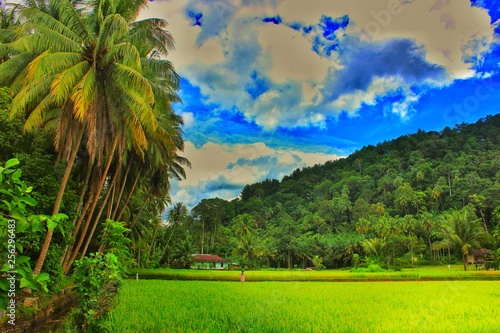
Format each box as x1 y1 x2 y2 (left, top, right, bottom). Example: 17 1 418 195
138 0 500 208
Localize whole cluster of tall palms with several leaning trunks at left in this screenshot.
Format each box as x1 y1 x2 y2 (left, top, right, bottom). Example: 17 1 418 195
0 0 190 274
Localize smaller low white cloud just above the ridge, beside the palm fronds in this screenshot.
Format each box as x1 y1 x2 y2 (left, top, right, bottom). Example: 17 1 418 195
171 141 339 207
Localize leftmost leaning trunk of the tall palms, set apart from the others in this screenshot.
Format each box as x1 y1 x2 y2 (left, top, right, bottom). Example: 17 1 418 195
33 128 84 274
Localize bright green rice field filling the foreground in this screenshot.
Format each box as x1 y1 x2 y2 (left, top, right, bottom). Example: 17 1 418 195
100 280 500 333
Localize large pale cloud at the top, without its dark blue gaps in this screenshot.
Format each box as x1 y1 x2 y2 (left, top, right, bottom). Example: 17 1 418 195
143 0 494 129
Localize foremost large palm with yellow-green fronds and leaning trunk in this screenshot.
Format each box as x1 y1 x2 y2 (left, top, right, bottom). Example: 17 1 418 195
0 0 186 274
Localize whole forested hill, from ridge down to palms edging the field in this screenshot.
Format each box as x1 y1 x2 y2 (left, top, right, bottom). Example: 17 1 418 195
188 115 500 267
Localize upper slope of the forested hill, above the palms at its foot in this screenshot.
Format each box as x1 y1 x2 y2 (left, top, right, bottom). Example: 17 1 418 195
235 115 500 220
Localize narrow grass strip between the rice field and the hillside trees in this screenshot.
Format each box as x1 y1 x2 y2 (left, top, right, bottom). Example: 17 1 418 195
131 265 500 282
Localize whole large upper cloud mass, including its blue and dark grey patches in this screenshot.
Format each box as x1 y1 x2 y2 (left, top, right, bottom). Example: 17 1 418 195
143 0 495 130
